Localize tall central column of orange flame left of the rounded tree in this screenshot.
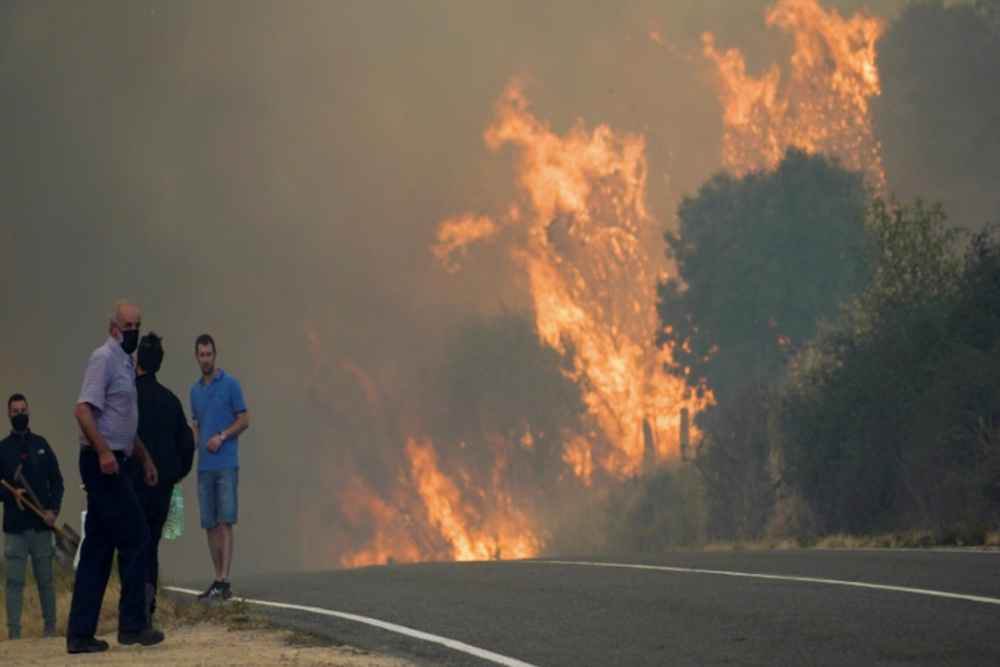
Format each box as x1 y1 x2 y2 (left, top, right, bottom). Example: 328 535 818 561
435 82 704 480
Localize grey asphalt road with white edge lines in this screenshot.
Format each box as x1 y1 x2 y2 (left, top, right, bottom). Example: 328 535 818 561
176 551 1000 666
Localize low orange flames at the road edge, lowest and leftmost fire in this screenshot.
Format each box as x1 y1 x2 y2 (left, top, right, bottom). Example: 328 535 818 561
299 323 544 567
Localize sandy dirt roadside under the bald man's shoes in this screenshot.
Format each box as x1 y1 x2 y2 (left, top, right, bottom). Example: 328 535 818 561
0 623 413 667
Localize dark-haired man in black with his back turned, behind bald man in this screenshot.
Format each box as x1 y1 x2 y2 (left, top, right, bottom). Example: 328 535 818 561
136 333 194 622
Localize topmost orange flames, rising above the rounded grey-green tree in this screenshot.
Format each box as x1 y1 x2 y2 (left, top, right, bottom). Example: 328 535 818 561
702 0 885 187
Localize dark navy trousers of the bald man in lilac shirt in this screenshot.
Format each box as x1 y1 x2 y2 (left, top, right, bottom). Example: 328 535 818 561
67 447 149 638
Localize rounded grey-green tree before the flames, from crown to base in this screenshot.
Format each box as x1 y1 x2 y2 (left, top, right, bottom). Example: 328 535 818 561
659 150 869 539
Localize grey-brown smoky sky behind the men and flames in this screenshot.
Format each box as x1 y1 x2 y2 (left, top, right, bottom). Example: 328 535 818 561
0 0 900 576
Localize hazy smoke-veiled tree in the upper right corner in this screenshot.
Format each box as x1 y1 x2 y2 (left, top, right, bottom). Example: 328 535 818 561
872 0 1000 229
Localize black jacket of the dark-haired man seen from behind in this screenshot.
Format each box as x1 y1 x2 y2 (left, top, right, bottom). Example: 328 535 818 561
135 373 194 488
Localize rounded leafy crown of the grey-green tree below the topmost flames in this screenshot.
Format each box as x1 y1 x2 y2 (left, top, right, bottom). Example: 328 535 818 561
659 150 869 402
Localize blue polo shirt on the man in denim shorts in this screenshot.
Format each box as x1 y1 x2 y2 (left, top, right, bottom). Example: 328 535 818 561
191 368 247 471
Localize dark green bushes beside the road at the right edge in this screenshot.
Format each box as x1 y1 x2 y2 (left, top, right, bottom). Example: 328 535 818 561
780 201 1000 541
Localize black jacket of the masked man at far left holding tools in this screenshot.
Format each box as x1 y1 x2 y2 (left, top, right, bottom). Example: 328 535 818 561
0 431 63 533
